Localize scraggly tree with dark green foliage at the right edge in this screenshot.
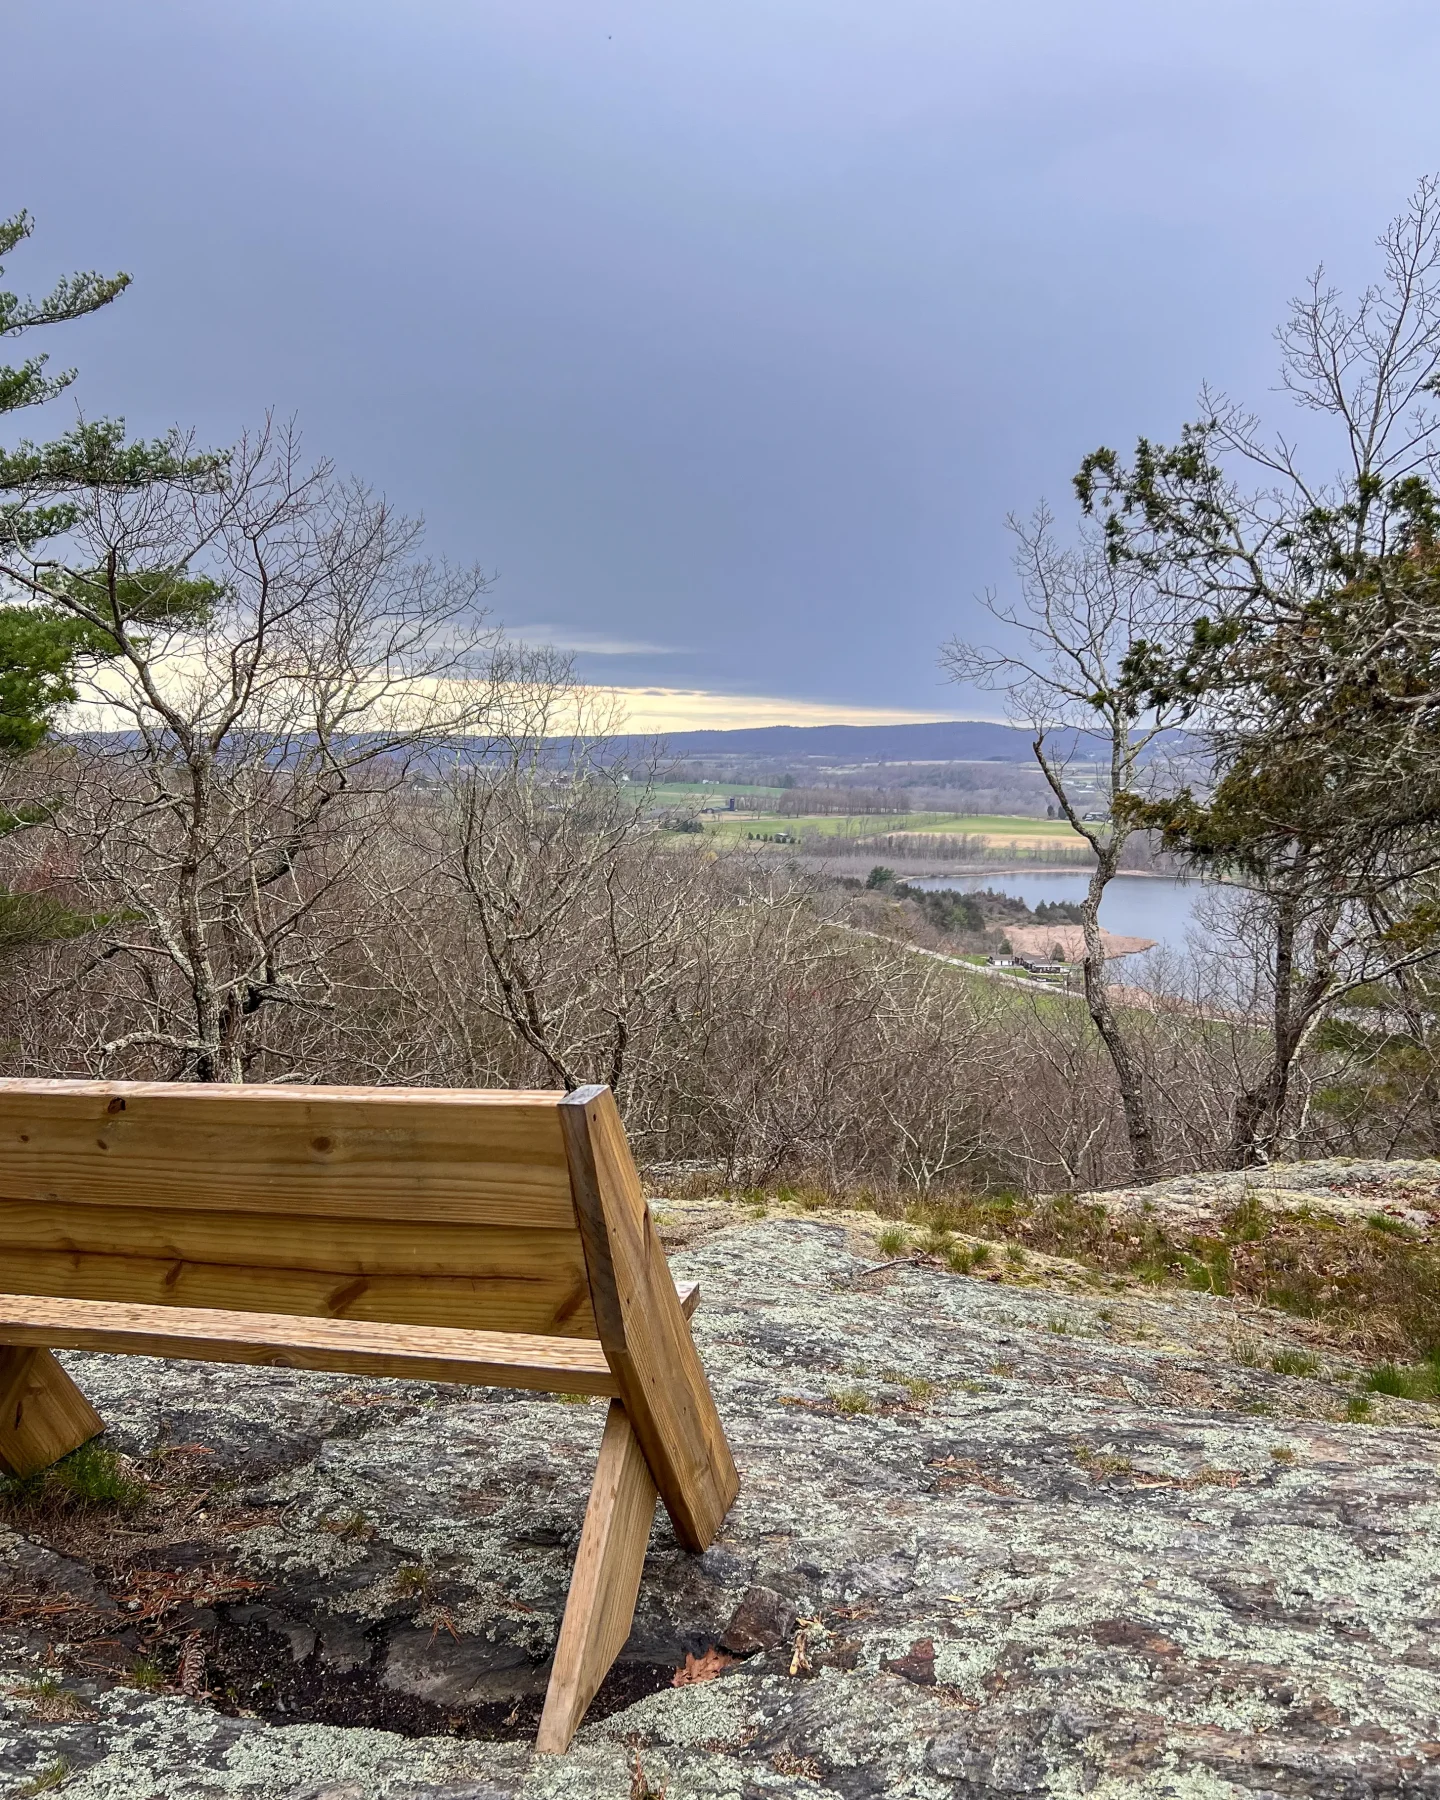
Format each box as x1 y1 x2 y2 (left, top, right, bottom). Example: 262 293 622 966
1076 178 1440 1163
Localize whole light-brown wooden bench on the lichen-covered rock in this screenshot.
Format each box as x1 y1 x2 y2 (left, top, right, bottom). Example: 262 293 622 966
0 1080 740 1751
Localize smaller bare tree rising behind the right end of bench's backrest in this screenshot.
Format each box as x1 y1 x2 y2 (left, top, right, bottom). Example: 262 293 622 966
365 666 711 1091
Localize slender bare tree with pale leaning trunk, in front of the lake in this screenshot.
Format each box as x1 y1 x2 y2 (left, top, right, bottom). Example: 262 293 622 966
943 508 1181 1181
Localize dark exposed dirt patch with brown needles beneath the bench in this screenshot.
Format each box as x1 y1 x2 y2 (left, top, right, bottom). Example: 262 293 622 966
0 1444 705 1742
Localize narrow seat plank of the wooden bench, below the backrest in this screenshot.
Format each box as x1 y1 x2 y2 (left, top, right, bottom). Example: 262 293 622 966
0 1294 616 1395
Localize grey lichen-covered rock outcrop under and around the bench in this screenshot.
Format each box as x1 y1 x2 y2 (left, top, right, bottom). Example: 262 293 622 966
0 1166 1440 1800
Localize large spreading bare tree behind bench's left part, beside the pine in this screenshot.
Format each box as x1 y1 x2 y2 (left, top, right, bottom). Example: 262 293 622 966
4 414 532 1082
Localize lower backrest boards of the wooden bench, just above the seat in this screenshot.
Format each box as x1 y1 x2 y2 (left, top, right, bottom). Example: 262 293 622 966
0 1201 596 1337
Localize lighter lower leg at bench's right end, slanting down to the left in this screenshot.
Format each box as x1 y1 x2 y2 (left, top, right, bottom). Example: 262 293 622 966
535 1400 659 1755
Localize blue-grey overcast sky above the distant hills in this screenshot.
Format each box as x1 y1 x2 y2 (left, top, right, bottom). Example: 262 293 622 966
0 0 1440 724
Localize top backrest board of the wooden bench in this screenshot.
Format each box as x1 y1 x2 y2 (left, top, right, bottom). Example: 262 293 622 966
0 1080 574 1229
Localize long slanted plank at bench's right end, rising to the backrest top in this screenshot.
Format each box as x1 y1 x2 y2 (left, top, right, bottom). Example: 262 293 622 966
560 1087 740 1550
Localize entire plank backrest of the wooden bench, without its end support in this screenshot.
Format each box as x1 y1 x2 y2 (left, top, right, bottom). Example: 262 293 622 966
0 1080 598 1337
